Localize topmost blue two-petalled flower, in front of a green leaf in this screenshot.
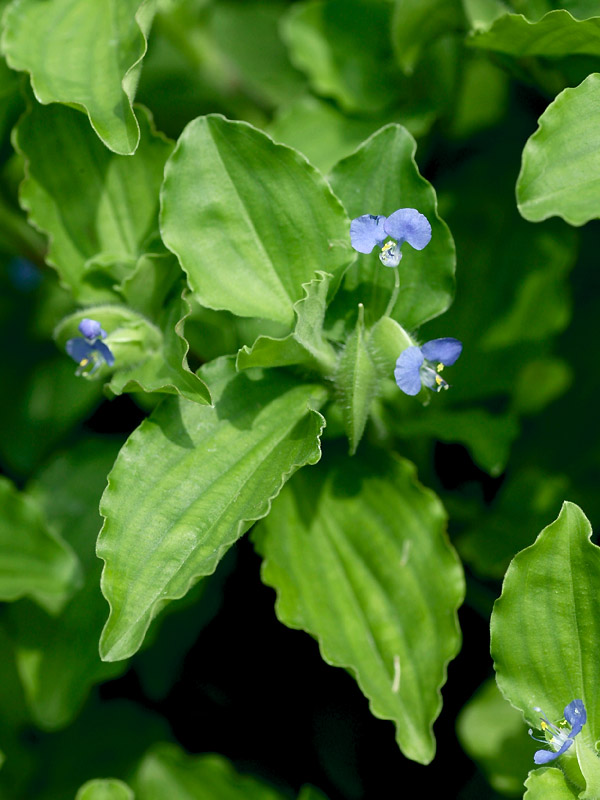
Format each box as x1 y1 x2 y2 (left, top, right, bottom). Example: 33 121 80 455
350 208 431 267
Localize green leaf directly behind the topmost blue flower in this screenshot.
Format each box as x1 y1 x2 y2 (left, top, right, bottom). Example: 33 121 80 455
331 125 456 330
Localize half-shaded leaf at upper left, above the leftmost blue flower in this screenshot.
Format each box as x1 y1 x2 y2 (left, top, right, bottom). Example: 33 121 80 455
15 100 173 303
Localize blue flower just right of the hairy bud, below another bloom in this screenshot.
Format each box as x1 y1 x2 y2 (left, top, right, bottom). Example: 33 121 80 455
394 338 462 395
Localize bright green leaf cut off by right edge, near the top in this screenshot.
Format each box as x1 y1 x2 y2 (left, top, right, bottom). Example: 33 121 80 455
517 74 600 225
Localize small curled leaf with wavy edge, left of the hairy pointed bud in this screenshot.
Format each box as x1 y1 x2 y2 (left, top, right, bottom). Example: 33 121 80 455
236 271 336 375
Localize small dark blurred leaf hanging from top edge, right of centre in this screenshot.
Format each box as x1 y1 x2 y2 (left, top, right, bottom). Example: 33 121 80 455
392 0 464 73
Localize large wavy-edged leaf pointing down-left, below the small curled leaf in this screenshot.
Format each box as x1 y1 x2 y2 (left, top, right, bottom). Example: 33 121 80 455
97 359 326 661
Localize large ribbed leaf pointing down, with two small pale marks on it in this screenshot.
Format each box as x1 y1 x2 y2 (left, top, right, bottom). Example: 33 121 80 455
255 449 464 764
